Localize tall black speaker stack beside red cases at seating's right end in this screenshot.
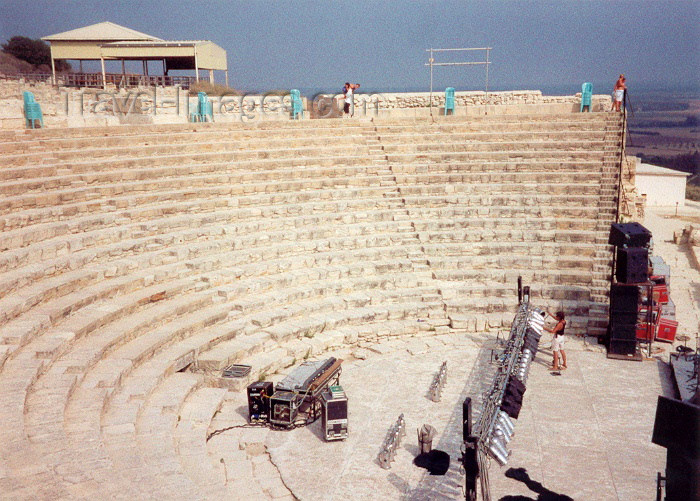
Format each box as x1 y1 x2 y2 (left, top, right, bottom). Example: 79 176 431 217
607 223 651 357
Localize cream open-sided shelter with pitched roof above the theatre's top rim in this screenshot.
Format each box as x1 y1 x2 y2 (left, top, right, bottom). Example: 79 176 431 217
42 21 228 86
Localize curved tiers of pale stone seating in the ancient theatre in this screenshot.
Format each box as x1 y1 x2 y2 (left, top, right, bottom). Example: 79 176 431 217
0 107 623 499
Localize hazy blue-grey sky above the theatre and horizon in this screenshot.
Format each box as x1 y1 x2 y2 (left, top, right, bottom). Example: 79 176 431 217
0 0 700 93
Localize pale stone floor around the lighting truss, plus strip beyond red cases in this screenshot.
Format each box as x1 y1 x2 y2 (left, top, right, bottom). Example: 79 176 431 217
208 203 698 500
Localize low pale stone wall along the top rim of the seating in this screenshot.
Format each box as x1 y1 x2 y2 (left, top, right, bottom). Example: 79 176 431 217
0 79 611 129
